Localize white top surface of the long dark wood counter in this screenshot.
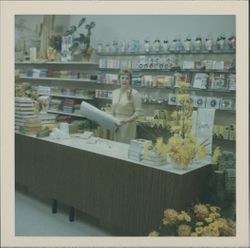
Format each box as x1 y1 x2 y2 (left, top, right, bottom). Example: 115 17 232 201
16 132 210 175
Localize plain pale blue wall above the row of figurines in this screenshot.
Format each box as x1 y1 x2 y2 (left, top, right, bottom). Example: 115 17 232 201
70 15 235 45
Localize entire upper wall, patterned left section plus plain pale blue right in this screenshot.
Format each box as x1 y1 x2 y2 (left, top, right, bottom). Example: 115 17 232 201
15 15 235 48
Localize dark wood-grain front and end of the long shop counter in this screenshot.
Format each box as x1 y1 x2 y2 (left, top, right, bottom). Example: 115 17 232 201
15 134 210 235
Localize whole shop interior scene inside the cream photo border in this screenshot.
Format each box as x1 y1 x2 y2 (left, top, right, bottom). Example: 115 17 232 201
15 15 236 236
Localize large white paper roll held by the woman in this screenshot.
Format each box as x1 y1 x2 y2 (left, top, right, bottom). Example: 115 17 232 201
80 101 120 131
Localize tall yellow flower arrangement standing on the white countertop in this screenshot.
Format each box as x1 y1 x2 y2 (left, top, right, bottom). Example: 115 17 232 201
152 83 208 169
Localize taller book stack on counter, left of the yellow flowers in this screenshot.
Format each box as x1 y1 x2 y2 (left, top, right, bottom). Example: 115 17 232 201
128 139 152 161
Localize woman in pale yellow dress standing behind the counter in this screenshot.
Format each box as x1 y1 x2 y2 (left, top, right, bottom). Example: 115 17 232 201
112 70 141 143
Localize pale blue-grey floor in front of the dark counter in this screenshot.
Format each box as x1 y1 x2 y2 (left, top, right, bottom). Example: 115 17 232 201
15 191 112 236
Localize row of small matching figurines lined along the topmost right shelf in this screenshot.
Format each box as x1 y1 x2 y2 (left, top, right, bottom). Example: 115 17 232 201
96 34 236 53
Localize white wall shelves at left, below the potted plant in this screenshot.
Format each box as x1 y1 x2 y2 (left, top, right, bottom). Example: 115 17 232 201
15 61 98 122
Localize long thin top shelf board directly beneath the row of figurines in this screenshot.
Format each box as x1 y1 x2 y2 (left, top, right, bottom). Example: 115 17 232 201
96 49 235 56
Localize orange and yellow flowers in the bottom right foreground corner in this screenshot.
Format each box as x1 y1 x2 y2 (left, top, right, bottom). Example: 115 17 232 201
149 204 236 237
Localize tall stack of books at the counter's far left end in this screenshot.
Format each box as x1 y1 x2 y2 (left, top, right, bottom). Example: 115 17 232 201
15 97 41 134
